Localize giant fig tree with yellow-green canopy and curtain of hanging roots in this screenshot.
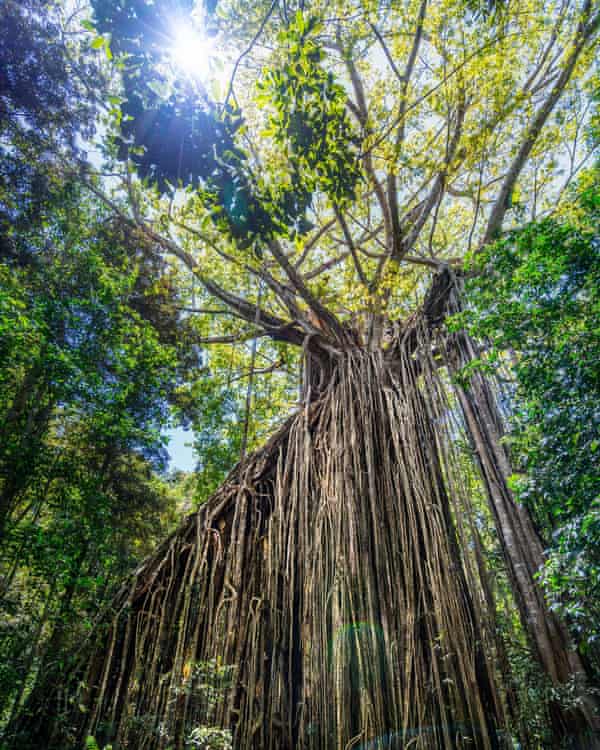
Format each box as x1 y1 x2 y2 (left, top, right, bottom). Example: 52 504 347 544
2 0 600 748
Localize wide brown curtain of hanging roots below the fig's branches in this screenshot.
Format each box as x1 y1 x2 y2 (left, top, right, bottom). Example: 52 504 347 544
34 326 504 750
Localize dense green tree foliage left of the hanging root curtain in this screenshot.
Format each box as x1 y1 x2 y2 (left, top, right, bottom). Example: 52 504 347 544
0 151 204 740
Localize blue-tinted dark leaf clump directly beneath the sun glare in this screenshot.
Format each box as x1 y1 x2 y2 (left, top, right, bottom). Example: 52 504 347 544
93 0 270 244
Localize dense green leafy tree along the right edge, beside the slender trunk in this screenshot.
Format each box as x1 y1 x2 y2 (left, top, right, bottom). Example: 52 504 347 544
465 159 600 652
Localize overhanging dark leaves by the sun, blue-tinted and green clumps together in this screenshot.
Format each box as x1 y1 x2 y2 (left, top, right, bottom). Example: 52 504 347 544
94 0 358 247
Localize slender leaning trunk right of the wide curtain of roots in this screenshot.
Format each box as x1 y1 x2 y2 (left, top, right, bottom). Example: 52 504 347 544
451 297 600 750
